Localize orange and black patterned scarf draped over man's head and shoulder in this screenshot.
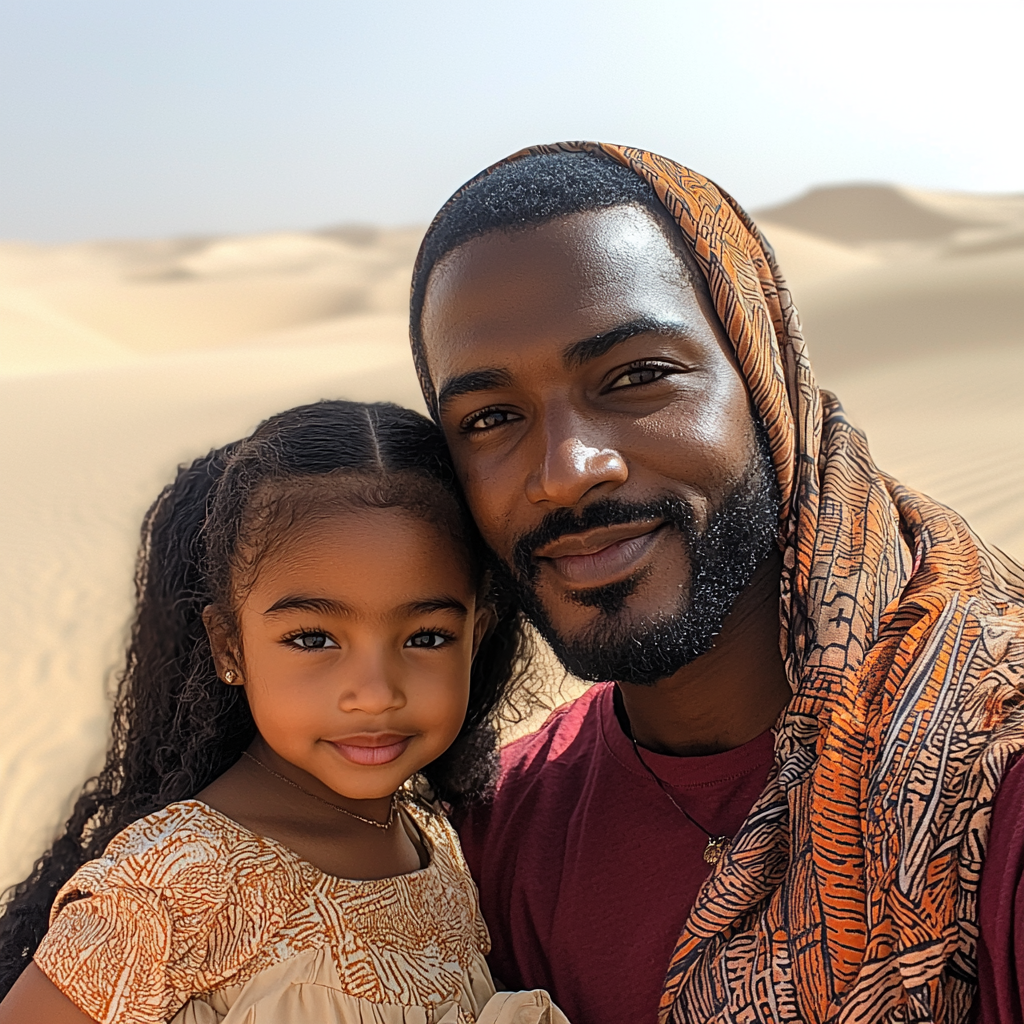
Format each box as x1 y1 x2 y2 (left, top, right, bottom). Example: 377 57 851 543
411 142 1024 1024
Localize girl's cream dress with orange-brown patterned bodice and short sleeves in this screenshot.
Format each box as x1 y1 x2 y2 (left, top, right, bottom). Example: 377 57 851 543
35 800 567 1024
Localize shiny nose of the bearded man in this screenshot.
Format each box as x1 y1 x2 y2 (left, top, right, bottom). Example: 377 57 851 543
526 405 629 508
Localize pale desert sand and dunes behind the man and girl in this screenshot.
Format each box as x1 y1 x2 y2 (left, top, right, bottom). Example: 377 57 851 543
0 185 1024 886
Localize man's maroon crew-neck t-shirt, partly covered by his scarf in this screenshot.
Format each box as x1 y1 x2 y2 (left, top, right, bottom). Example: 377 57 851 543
460 683 1024 1024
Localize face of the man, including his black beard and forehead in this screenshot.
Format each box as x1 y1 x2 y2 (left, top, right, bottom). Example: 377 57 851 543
415 207 777 683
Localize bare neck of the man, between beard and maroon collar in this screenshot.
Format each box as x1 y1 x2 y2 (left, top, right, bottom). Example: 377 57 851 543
617 553 793 756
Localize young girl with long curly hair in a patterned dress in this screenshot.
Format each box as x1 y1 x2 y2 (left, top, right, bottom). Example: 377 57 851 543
0 401 565 1024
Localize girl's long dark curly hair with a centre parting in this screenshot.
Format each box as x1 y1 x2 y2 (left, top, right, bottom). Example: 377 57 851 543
0 401 527 998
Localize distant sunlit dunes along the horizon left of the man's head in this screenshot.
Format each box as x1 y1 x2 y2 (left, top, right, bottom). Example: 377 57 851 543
0 228 421 372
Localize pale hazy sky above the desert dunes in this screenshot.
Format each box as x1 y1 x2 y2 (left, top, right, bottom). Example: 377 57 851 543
0 0 1024 241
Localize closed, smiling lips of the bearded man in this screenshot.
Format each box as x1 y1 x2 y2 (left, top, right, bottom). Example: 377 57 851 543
534 520 668 587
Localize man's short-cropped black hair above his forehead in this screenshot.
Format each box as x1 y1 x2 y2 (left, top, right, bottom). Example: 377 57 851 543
410 153 685 417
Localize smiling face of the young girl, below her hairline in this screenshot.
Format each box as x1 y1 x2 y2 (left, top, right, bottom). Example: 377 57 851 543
212 510 487 800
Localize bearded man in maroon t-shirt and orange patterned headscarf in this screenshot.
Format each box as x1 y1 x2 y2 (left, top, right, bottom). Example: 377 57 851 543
412 143 1024 1024
